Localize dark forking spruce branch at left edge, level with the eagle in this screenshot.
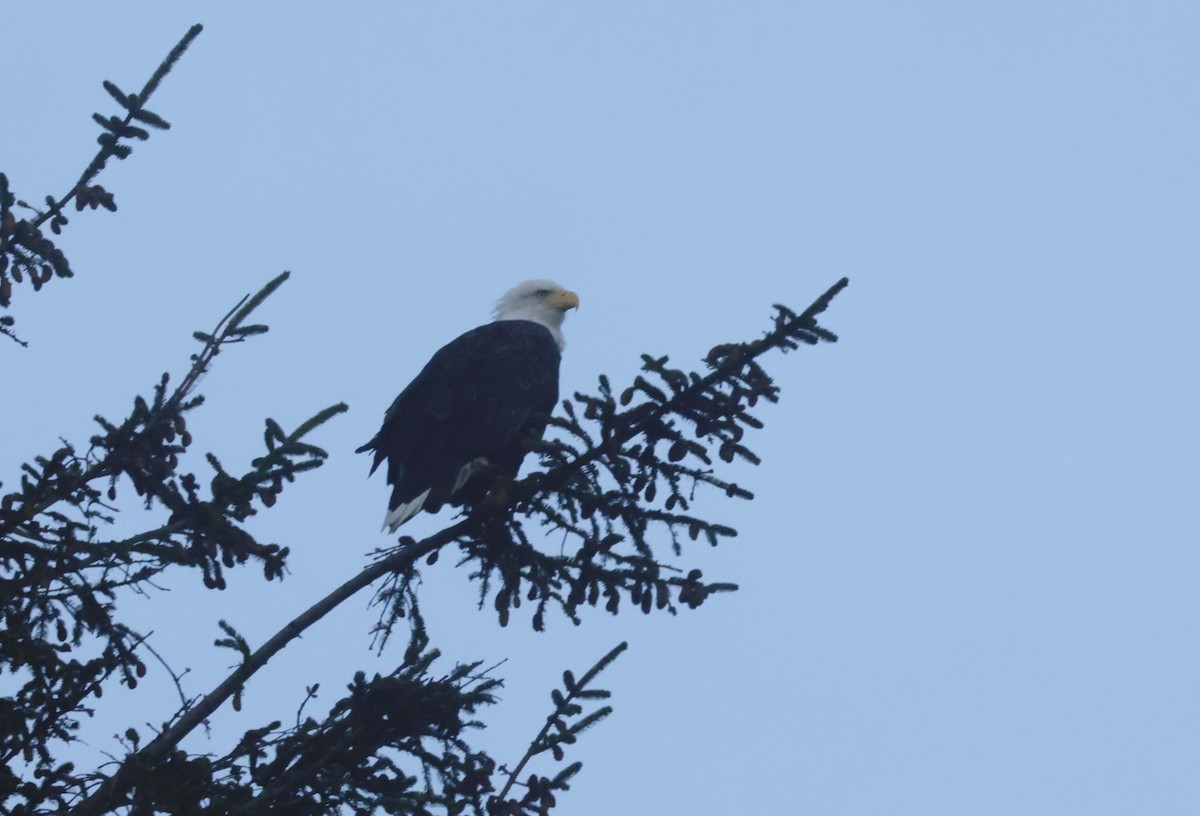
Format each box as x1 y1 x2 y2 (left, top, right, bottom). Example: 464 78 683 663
0 274 346 792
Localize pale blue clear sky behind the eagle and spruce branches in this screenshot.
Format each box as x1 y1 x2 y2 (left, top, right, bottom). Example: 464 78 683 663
0 2 1200 816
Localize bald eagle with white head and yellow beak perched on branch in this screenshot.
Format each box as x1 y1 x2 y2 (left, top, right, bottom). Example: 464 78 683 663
358 281 580 533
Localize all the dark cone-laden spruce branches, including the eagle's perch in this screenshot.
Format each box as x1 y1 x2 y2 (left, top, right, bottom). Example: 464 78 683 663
0 25 846 816
